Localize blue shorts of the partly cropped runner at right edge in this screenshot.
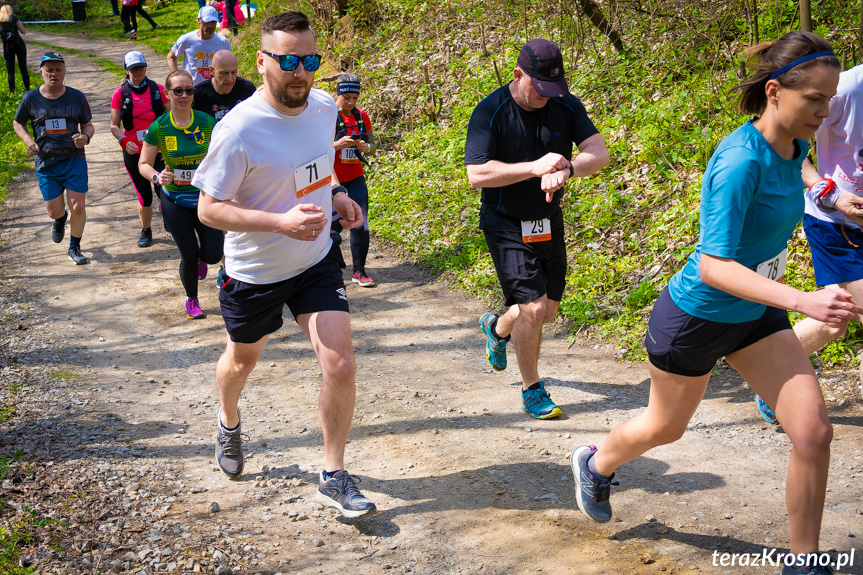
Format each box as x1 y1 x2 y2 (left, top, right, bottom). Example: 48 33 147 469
803 214 863 286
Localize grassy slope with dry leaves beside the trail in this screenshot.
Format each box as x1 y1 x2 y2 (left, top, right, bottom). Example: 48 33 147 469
27 0 857 359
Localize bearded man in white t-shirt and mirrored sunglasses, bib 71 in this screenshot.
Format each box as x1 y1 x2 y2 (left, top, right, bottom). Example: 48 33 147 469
192 12 377 517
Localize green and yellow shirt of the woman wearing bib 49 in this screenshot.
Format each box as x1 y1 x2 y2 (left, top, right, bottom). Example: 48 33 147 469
144 110 216 208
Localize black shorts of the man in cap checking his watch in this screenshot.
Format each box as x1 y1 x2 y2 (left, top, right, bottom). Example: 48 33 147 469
479 210 566 306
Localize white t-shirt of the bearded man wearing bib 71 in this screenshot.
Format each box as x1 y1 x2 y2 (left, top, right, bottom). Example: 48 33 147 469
192 88 338 284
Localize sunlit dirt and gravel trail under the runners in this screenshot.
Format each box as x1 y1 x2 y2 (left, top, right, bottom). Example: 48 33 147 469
0 33 863 574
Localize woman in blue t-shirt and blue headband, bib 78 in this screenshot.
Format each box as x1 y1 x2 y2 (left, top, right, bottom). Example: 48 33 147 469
571 32 863 575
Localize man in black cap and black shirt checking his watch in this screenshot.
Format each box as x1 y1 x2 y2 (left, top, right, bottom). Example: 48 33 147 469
465 38 609 419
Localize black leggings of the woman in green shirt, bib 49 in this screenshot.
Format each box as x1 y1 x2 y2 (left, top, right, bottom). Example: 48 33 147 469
159 195 225 297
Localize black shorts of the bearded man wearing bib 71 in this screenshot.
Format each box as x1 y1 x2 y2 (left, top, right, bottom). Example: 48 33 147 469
219 238 349 343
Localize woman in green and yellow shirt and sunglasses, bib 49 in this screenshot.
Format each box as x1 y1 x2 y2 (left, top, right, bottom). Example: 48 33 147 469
138 70 224 319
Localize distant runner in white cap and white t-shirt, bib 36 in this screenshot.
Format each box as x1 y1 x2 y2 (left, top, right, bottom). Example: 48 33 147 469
168 6 231 86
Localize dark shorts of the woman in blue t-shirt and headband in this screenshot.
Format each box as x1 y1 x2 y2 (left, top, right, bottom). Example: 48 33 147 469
644 288 791 377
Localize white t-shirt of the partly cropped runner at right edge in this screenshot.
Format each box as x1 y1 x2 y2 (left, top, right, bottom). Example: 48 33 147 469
806 64 863 229
